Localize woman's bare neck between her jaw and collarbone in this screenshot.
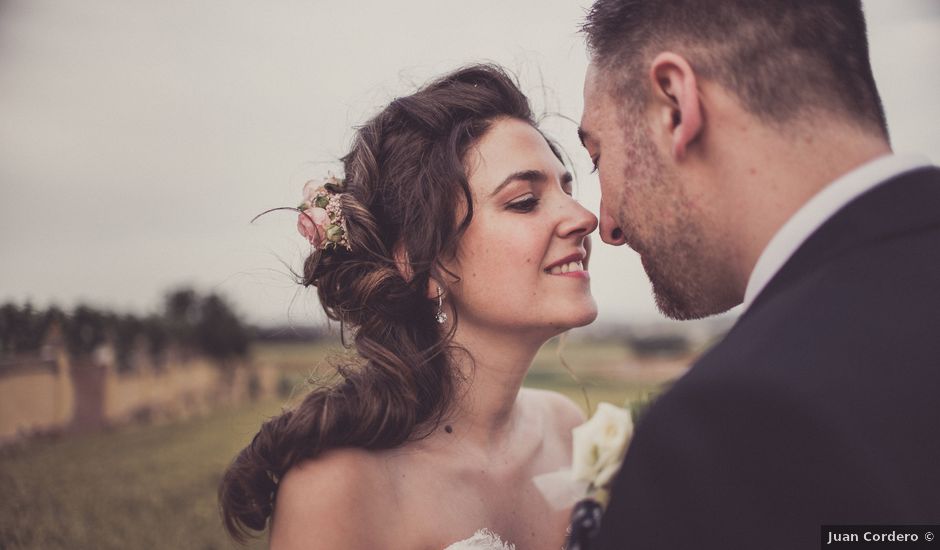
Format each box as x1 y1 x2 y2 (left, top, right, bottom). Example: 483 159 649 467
438 329 544 448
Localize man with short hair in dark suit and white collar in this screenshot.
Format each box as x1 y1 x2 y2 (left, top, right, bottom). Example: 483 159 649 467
580 0 940 550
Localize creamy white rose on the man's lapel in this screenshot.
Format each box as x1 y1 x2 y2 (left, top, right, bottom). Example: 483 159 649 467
571 403 633 505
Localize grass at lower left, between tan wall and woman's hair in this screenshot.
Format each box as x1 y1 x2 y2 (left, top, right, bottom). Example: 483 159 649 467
0 401 278 550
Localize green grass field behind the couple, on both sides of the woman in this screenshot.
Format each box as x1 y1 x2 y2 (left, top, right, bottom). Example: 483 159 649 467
0 343 692 550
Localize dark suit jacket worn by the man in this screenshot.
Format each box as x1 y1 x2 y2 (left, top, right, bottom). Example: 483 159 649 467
592 168 940 550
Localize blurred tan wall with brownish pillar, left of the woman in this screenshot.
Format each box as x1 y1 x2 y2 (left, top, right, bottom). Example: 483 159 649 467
0 348 278 445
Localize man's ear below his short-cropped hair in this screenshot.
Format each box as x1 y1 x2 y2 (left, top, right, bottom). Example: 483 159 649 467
649 52 702 161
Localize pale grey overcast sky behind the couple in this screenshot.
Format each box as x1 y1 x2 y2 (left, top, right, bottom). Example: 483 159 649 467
0 0 940 324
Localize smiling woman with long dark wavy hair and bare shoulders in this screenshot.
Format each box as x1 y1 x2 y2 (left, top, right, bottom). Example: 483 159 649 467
219 65 597 550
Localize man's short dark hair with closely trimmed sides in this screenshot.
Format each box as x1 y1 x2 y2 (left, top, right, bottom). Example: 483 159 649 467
582 0 888 137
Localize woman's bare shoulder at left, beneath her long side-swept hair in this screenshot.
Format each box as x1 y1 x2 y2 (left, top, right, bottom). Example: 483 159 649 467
270 449 393 550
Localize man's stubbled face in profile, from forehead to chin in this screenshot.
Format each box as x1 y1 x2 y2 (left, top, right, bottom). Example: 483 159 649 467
579 64 730 319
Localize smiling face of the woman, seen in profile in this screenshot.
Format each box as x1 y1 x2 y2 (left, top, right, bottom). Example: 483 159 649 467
448 119 597 336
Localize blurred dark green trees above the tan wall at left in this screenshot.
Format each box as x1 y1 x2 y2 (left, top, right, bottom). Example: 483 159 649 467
0 288 252 370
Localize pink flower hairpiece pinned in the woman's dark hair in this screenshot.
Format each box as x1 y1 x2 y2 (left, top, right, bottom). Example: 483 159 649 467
251 174 352 252
